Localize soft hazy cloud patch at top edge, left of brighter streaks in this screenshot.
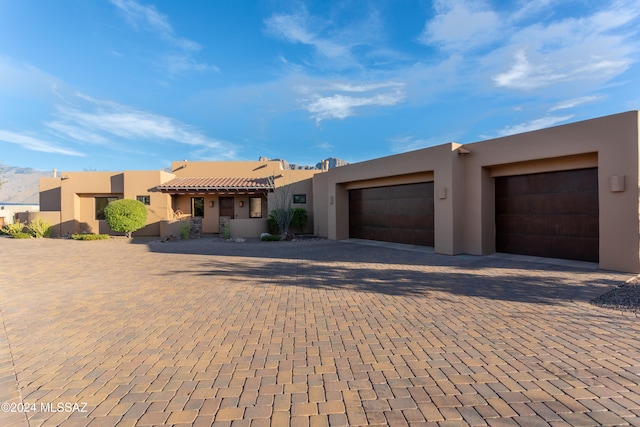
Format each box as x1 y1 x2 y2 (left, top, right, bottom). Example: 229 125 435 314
418 0 502 51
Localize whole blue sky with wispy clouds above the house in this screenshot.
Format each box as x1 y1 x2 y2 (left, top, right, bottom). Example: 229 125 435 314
0 0 640 171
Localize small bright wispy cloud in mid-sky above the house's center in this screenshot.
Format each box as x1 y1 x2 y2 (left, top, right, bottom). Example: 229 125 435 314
299 82 405 124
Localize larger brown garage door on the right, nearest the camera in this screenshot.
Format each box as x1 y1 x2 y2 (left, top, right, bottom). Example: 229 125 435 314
495 168 599 262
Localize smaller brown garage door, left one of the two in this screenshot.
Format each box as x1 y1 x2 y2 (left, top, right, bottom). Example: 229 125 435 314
349 182 433 246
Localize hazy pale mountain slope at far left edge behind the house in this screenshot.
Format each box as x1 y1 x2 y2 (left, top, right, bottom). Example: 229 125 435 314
0 165 53 205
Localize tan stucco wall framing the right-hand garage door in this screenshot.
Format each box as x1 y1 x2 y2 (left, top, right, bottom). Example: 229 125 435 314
463 111 640 272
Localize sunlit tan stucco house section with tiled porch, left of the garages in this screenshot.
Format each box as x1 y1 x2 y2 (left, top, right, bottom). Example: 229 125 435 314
40 160 317 241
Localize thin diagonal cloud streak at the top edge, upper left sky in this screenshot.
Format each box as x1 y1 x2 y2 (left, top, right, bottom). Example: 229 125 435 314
111 0 219 74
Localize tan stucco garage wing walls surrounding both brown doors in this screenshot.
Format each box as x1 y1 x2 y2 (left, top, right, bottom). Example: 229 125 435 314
313 111 640 272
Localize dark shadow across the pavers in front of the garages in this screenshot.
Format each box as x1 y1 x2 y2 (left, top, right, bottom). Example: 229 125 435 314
142 239 624 305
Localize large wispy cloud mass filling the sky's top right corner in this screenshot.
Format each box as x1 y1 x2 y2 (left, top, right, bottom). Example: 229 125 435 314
418 0 640 95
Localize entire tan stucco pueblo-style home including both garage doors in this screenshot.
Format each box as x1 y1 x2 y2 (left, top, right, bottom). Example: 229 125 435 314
40 111 640 273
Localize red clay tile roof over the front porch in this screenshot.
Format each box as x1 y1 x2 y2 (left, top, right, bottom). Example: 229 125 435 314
156 177 274 193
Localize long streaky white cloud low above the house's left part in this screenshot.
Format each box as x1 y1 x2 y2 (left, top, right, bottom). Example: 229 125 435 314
45 94 235 158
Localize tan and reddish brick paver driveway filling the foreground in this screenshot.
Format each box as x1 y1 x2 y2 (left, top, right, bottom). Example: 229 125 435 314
0 238 640 426
